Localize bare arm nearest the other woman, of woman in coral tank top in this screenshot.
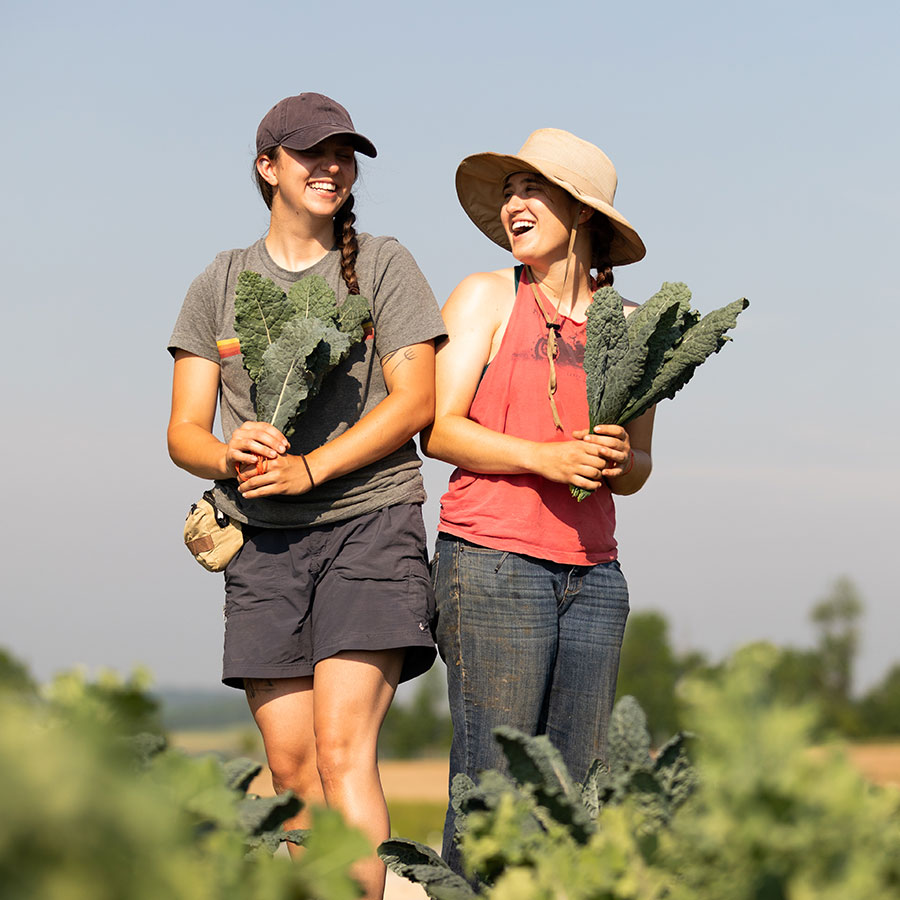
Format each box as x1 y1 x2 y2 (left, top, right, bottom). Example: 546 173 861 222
422 272 606 490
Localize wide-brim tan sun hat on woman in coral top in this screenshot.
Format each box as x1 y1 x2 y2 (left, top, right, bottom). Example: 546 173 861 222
456 128 647 266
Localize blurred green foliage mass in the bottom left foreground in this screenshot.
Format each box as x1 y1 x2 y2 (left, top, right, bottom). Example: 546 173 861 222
0 652 371 900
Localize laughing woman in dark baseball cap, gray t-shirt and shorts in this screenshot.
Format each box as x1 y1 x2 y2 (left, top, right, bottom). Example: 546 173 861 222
168 93 444 898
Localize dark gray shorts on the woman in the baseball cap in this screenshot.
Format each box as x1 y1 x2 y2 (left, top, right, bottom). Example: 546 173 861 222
222 503 435 688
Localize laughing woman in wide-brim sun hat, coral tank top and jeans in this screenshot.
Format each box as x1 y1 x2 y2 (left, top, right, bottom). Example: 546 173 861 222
424 128 653 868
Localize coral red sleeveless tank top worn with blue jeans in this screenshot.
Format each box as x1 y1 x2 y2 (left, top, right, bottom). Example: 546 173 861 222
440 267 616 565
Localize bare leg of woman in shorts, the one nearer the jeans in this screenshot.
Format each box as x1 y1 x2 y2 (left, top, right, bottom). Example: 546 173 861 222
313 650 404 900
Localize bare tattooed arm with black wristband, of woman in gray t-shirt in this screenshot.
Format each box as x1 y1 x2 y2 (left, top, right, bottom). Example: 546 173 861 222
238 341 434 498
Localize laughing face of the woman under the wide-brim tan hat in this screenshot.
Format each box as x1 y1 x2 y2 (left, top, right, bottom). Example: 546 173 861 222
500 172 579 264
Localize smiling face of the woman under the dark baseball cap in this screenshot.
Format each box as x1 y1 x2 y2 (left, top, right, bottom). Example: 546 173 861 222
257 136 356 219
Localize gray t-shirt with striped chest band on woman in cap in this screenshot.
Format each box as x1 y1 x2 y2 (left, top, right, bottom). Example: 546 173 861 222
169 234 445 528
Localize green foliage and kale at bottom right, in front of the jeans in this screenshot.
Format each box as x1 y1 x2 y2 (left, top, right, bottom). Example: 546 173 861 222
380 645 900 900
